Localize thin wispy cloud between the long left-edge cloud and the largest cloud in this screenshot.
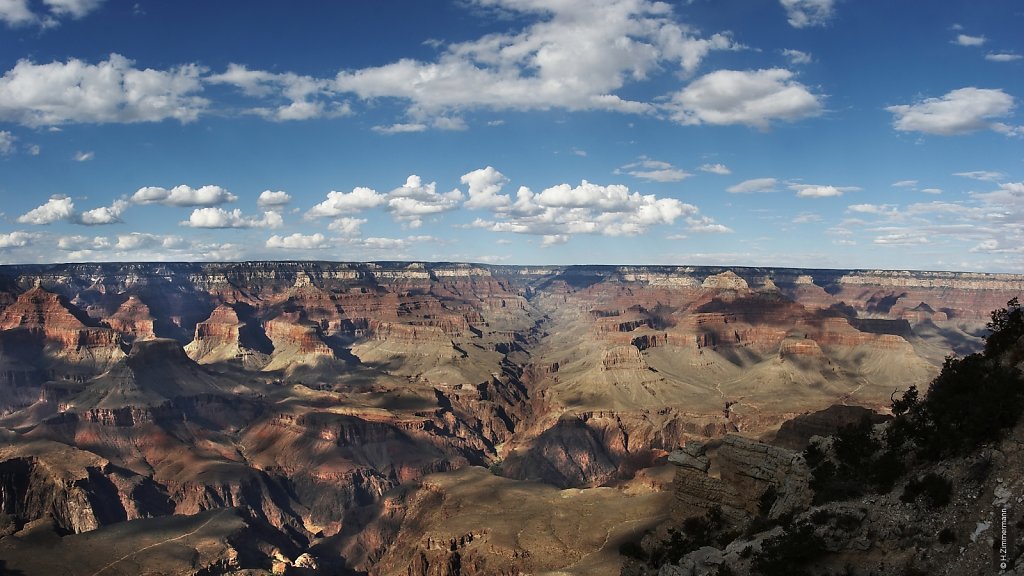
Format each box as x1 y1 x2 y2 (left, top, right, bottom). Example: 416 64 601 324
204 64 352 122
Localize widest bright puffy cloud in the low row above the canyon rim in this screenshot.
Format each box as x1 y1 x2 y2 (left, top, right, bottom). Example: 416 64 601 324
470 176 697 239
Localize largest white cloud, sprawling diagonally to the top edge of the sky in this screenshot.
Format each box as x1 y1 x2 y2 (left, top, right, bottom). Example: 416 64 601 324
336 0 739 121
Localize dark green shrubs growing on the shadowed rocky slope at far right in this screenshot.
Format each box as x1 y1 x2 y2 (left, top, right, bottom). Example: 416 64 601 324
804 298 1024 507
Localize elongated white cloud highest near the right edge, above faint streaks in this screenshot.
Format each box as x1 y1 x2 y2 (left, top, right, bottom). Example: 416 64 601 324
886 87 1015 136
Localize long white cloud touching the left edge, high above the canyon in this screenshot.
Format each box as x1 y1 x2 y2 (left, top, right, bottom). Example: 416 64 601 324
0 54 208 126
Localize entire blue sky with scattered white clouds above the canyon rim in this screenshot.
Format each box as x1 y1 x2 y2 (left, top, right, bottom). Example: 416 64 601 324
0 0 1024 273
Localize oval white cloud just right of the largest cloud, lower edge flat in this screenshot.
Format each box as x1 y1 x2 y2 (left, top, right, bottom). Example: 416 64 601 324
667 68 821 129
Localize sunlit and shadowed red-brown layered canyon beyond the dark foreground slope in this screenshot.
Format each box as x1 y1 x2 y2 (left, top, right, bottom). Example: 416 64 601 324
0 261 1024 576
